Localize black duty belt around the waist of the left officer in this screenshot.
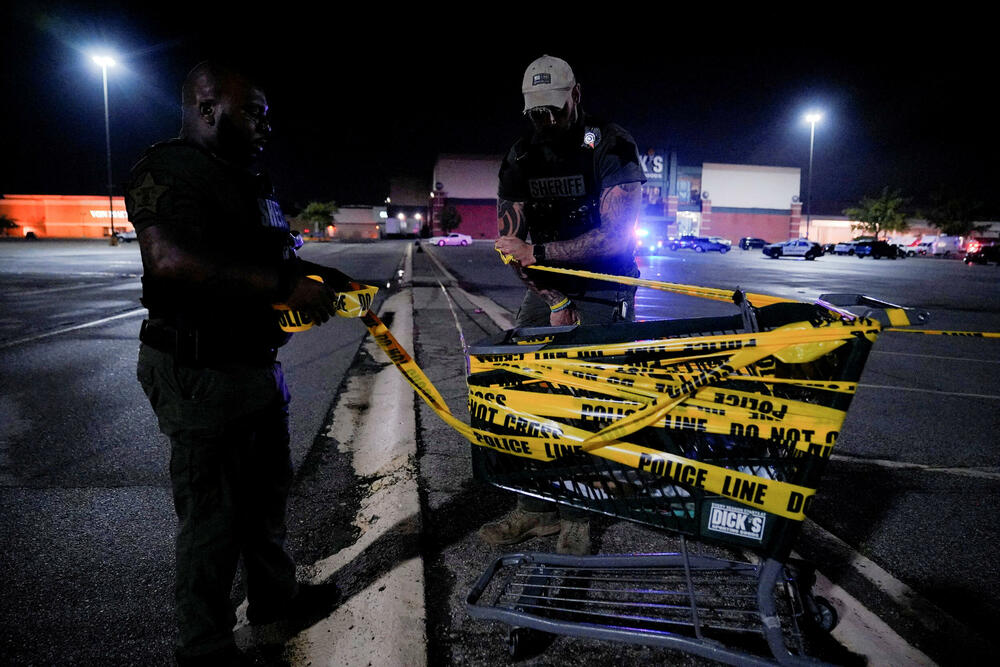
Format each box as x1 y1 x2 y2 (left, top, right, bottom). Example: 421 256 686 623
139 320 278 367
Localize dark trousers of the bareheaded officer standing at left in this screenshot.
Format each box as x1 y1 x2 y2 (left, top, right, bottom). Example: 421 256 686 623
137 345 297 657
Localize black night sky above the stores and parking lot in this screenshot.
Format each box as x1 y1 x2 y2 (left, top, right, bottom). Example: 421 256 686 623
0 0 1000 220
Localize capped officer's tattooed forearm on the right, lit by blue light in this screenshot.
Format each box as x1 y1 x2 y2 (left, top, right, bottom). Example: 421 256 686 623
545 183 642 261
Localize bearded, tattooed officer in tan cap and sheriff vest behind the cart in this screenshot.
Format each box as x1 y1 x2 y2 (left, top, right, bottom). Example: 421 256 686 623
488 55 645 554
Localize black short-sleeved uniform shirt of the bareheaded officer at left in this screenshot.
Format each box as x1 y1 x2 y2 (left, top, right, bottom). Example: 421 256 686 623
125 140 295 347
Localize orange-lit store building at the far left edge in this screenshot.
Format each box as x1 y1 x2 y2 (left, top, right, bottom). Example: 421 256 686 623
0 195 133 238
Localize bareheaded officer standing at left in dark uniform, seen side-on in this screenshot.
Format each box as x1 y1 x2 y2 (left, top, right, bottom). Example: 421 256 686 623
126 62 348 665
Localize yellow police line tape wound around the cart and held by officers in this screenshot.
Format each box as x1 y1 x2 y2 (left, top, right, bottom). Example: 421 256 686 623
275 266 1000 520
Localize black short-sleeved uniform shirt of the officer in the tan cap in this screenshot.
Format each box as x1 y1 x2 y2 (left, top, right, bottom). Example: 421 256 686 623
497 114 646 293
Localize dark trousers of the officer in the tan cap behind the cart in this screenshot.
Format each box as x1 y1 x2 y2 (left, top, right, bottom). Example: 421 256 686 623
514 285 635 521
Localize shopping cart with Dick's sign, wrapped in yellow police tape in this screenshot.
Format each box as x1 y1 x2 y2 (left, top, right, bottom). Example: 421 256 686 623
467 292 926 664
